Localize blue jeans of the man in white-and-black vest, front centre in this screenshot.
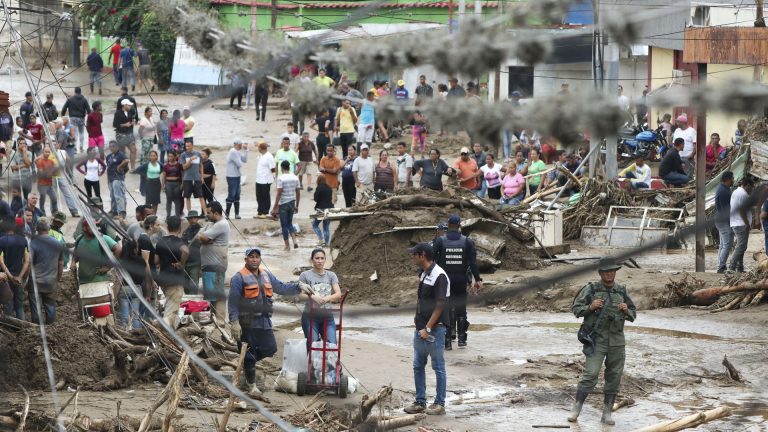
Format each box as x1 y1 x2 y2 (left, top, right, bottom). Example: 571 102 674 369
413 325 448 406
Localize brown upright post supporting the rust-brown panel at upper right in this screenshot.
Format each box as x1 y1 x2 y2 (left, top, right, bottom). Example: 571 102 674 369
694 63 707 272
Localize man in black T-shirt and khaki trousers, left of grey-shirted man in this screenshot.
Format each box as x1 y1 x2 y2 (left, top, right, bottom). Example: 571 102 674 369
155 216 189 328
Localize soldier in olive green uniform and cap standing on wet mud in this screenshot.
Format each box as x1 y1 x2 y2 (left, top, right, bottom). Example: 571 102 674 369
568 258 637 425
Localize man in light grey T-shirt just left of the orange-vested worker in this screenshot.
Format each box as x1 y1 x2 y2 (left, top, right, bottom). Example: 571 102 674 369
197 201 230 322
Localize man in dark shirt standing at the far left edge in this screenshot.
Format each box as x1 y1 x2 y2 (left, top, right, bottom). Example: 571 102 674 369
0 217 29 320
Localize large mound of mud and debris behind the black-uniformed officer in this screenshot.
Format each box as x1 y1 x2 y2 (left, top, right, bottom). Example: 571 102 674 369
326 187 541 304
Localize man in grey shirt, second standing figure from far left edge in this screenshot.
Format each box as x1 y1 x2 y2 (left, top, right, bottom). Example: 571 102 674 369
27 218 64 324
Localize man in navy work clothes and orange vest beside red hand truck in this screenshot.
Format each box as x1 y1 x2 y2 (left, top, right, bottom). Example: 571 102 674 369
228 248 299 395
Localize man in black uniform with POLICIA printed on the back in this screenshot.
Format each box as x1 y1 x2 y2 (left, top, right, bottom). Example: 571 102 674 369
434 214 483 351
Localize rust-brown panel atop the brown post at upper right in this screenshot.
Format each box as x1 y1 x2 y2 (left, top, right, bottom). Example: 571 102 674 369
683 27 768 65
